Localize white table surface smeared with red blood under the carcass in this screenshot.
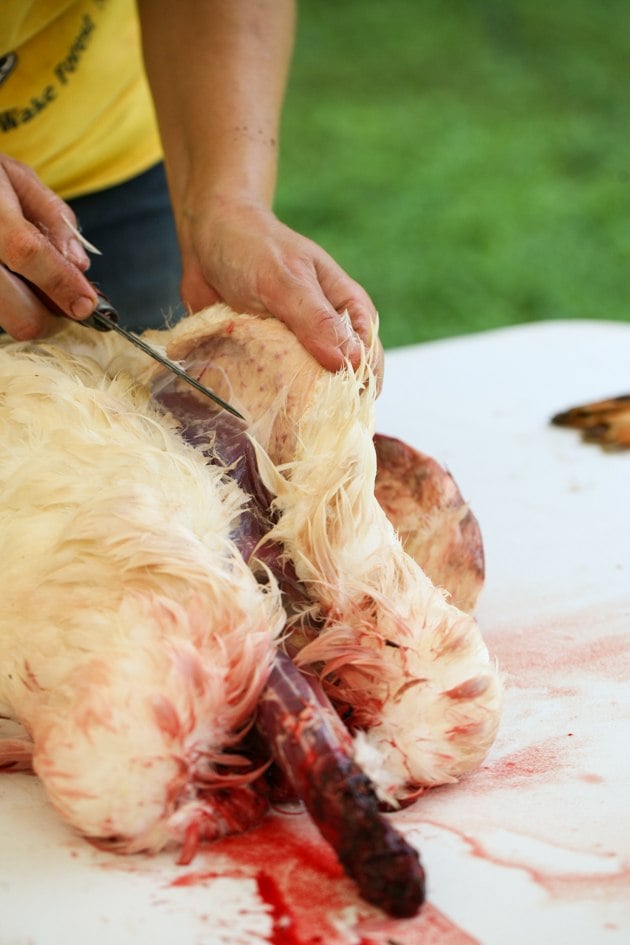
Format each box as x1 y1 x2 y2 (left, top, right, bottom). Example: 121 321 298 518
0 321 630 945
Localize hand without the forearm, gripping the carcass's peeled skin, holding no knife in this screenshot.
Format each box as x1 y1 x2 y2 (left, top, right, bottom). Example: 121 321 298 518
180 198 383 385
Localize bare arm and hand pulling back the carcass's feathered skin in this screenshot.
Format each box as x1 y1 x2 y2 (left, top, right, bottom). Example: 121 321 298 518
137 0 378 371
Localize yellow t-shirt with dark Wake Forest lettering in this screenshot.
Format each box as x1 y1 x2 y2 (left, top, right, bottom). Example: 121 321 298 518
0 0 162 197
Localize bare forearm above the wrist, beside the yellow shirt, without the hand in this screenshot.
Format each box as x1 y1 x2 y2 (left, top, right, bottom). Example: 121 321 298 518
138 0 295 216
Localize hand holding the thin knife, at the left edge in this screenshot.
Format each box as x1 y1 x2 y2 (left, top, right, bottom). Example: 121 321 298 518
0 154 97 340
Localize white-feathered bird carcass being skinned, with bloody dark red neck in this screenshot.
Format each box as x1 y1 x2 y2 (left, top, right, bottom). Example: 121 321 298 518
0 306 501 914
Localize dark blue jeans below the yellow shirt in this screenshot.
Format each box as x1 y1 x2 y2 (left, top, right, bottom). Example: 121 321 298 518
67 164 185 331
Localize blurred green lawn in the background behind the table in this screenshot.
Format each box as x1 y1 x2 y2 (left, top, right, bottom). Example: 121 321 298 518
276 0 630 347
